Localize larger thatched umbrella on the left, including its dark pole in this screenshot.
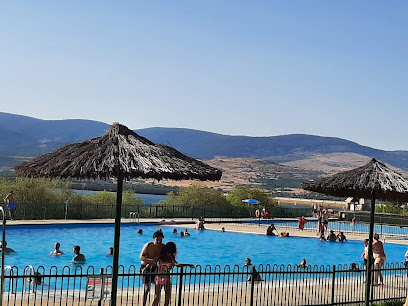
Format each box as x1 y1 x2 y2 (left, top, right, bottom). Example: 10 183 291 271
15 123 222 305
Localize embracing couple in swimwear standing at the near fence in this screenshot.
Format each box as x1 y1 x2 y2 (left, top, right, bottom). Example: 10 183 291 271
140 229 194 306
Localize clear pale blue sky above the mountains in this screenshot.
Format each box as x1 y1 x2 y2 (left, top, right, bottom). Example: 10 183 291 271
0 0 408 150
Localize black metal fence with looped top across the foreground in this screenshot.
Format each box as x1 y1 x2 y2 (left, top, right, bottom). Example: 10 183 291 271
3 263 408 306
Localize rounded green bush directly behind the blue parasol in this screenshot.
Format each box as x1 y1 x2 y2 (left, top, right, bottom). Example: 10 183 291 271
227 186 278 207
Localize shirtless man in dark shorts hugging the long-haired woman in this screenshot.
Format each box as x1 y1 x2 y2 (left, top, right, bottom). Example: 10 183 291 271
140 229 164 306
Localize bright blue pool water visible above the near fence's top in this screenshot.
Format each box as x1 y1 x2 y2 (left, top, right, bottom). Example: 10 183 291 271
1 224 407 269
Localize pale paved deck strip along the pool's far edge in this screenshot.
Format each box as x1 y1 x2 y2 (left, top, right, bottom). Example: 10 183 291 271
7 218 408 245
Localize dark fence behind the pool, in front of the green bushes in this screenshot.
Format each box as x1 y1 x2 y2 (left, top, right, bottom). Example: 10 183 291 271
10 203 312 220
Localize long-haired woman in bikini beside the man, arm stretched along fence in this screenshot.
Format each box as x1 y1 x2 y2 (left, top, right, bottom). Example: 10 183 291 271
152 241 194 306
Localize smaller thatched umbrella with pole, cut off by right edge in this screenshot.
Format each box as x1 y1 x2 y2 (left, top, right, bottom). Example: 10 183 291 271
302 158 408 305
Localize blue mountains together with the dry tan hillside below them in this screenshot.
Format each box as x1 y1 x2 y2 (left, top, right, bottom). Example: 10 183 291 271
0 113 408 188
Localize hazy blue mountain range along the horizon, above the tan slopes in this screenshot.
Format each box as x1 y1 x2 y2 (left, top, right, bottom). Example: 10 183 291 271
0 112 408 177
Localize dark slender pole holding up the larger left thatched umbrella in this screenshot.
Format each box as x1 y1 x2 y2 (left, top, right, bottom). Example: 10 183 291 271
111 174 123 306
